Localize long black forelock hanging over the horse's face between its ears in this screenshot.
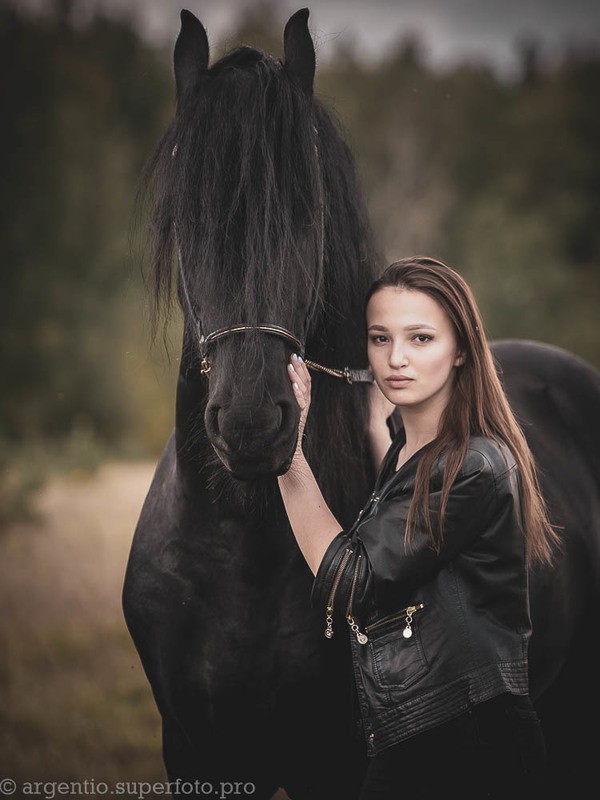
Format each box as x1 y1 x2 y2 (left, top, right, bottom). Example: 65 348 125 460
155 49 323 332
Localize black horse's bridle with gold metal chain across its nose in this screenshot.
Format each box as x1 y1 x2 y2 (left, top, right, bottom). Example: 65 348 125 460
172 129 373 383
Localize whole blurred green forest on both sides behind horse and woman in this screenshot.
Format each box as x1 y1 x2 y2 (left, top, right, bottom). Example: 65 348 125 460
0 3 600 505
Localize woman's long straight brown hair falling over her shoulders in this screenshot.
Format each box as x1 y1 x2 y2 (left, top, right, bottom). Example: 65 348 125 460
365 256 559 564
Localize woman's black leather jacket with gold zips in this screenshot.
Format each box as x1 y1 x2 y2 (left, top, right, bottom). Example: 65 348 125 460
312 431 531 755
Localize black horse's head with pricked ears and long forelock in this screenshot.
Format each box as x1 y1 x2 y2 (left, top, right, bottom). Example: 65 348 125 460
145 9 376 500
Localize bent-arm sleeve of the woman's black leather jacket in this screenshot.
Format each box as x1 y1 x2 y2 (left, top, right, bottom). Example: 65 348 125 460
312 453 501 609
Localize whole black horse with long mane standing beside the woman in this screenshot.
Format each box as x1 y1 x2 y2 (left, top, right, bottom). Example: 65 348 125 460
123 9 600 800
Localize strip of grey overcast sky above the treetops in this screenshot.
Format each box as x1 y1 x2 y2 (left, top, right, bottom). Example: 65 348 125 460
16 0 600 73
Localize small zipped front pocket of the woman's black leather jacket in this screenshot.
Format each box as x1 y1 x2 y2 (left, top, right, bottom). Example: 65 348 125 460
365 603 429 689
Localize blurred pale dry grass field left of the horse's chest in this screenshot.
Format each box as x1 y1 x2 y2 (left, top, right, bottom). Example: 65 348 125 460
0 463 165 796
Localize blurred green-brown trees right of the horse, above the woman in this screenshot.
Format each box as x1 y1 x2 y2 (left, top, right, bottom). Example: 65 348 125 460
318 33 600 366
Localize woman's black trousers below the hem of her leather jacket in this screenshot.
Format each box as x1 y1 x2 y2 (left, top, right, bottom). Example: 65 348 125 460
359 695 546 800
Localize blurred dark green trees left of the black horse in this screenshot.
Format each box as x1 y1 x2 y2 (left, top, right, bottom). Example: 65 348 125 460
0 2 172 444
